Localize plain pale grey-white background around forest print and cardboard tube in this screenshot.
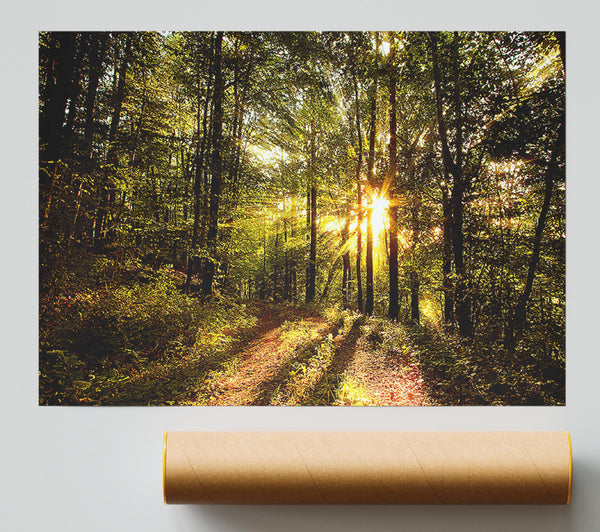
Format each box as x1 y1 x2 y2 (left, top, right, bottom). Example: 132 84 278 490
0 0 600 532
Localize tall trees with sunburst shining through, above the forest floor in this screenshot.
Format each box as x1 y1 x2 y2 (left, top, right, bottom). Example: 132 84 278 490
39 31 566 406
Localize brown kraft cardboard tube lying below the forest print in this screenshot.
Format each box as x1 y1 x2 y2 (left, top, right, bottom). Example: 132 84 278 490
163 432 572 504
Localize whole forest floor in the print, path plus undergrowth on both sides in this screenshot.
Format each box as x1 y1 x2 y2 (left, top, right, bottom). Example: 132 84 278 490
40 251 564 406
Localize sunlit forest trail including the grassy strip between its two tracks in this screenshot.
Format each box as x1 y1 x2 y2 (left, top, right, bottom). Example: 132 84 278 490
208 303 431 406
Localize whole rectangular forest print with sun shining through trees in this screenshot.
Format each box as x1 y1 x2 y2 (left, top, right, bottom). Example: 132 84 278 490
38 31 566 406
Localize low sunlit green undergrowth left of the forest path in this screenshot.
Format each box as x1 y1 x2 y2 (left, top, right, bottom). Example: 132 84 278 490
40 247 252 404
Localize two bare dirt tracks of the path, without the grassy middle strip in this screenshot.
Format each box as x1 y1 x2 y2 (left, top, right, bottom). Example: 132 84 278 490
208 303 431 406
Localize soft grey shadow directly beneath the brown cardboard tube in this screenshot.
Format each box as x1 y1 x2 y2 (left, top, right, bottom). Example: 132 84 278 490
182 505 572 532
